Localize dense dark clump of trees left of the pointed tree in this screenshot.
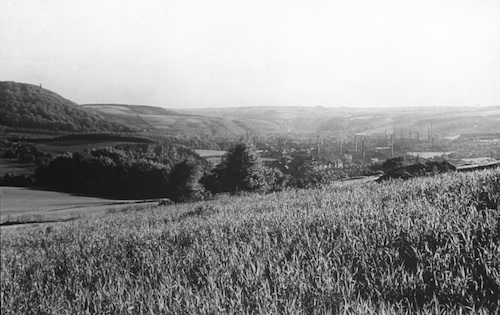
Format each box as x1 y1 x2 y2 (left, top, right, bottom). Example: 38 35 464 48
34 145 203 201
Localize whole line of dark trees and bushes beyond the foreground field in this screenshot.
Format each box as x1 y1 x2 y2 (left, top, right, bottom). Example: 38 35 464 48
0 143 344 202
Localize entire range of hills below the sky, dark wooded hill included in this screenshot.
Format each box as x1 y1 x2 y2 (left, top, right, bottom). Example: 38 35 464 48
0 82 500 139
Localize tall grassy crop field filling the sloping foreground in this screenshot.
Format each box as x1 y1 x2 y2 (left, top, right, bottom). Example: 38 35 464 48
0 169 500 314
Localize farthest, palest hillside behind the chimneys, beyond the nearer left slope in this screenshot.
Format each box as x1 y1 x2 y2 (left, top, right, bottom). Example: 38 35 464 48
178 106 500 137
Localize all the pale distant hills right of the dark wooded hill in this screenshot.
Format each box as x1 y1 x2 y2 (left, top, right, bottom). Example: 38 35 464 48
82 104 500 138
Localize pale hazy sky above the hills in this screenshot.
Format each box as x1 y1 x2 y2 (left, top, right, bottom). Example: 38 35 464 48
0 0 500 108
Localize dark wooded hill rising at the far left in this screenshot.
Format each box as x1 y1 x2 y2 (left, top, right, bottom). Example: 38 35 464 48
0 81 132 132
